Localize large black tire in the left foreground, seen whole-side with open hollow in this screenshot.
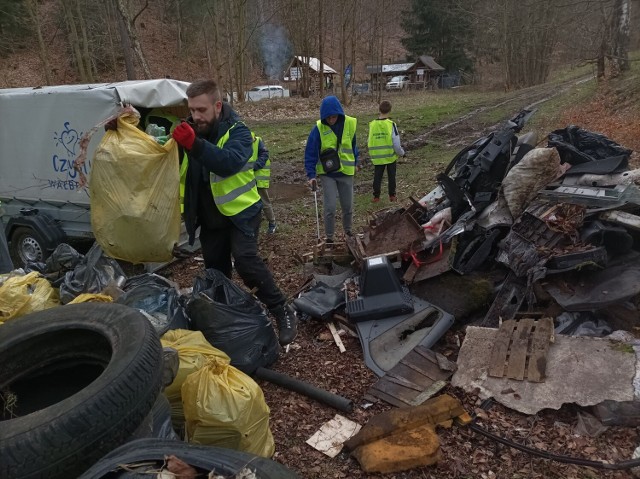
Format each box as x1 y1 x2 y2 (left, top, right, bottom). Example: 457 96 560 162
0 303 162 479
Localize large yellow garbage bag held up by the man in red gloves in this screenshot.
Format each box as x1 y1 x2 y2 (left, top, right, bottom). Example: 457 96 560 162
89 113 180 263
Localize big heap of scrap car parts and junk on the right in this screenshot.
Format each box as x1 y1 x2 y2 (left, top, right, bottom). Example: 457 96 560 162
348 110 640 327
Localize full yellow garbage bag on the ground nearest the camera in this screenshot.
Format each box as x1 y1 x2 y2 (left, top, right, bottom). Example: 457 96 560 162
182 359 275 457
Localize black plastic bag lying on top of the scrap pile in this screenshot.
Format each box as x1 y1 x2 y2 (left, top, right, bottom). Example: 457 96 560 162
548 125 631 169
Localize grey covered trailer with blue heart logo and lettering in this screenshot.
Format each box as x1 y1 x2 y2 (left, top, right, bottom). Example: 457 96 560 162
0 79 189 267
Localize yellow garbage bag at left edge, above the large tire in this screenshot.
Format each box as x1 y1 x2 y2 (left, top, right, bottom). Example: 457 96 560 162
0 271 60 322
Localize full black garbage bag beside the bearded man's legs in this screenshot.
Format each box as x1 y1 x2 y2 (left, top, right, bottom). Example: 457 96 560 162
186 269 279 374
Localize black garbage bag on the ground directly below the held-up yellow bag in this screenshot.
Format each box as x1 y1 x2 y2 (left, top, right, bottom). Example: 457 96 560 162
60 243 126 304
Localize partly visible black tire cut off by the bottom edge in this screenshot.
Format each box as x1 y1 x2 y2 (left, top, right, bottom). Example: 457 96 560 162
79 439 298 479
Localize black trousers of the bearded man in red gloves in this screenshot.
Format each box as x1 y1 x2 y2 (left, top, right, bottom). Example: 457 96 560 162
200 214 286 309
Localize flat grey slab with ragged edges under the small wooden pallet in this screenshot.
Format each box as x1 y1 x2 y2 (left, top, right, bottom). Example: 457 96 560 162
451 326 636 414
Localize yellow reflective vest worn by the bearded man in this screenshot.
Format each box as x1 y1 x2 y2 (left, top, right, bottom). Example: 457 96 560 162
209 123 260 216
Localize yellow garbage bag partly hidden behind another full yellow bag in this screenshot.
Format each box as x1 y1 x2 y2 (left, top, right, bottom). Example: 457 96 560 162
160 329 231 429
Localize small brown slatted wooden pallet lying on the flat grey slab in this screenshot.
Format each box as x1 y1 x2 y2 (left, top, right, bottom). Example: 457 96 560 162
489 318 553 382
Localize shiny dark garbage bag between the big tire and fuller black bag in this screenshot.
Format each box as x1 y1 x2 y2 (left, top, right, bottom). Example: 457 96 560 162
116 273 189 336
